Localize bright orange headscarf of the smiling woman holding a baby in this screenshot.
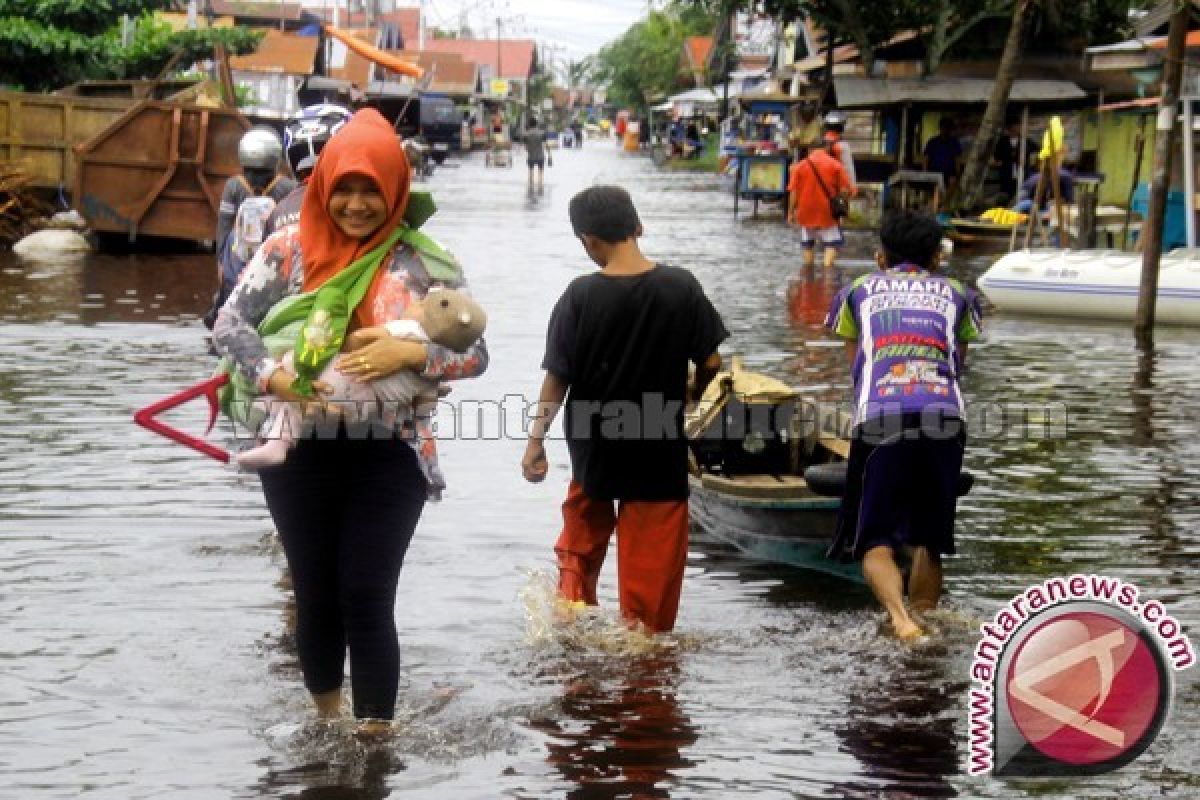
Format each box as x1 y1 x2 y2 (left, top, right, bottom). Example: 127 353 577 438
300 108 410 325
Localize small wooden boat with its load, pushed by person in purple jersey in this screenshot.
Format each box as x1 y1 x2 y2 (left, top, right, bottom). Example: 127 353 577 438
686 360 863 582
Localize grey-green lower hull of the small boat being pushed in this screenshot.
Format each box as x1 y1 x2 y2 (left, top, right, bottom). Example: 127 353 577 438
688 477 863 583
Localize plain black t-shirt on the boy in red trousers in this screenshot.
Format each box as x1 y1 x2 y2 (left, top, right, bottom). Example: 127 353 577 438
541 264 728 501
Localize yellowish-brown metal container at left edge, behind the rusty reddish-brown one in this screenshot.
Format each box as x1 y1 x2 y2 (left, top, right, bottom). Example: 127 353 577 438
0 91 133 190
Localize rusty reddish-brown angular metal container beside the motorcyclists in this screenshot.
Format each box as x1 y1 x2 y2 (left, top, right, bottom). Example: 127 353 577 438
74 101 250 241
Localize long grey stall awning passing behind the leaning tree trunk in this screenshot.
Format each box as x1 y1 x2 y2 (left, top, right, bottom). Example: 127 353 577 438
833 76 1087 108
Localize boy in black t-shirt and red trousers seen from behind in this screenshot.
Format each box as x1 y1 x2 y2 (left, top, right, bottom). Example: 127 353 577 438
521 186 728 632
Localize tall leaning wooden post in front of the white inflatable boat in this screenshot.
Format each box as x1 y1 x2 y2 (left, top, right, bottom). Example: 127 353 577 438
1133 2 1192 344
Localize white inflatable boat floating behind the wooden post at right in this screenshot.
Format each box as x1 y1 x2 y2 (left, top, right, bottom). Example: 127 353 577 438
978 248 1200 325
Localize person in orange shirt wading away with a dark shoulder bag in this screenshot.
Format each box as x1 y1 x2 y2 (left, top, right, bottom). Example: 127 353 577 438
787 142 857 269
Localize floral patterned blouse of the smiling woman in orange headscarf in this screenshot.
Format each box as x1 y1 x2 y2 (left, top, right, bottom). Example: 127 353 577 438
212 225 487 500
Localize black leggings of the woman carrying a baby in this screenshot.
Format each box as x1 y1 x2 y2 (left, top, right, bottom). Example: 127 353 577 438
260 435 426 720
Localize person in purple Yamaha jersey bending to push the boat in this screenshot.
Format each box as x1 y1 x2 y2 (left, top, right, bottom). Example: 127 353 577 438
826 211 980 640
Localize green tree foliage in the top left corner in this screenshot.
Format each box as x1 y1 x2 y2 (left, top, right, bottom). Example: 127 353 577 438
0 0 262 90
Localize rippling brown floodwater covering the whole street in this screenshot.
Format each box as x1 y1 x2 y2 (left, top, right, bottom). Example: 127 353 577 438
0 143 1200 800
